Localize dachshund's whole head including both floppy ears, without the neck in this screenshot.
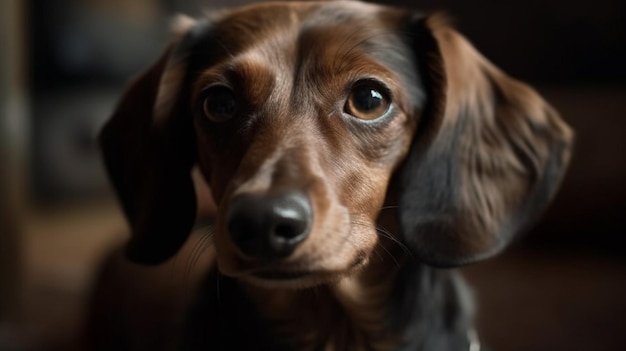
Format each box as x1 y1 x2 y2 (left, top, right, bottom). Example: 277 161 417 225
101 1 573 285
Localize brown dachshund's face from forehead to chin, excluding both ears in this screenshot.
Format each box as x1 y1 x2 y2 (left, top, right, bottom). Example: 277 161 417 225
191 3 424 284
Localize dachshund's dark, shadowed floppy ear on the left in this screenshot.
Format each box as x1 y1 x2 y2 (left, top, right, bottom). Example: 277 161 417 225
99 16 196 264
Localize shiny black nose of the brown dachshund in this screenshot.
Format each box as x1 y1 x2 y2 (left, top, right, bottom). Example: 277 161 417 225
227 192 313 258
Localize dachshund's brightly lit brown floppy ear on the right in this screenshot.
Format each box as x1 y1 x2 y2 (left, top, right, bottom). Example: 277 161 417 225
399 16 573 266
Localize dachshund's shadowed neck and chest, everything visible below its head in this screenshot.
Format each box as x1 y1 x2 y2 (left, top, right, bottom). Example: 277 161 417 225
183 243 471 351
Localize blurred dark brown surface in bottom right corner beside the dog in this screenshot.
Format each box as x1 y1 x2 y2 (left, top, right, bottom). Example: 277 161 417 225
465 251 626 351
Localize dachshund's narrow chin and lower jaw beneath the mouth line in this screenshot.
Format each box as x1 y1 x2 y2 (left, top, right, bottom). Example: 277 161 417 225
229 256 367 290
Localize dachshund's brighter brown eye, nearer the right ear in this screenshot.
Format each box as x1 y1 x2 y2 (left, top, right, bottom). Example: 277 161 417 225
344 82 390 120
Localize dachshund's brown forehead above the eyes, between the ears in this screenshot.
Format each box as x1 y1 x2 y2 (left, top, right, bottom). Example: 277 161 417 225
190 1 420 107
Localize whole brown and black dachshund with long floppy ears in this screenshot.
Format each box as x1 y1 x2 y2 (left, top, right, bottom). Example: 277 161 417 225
100 1 574 351
